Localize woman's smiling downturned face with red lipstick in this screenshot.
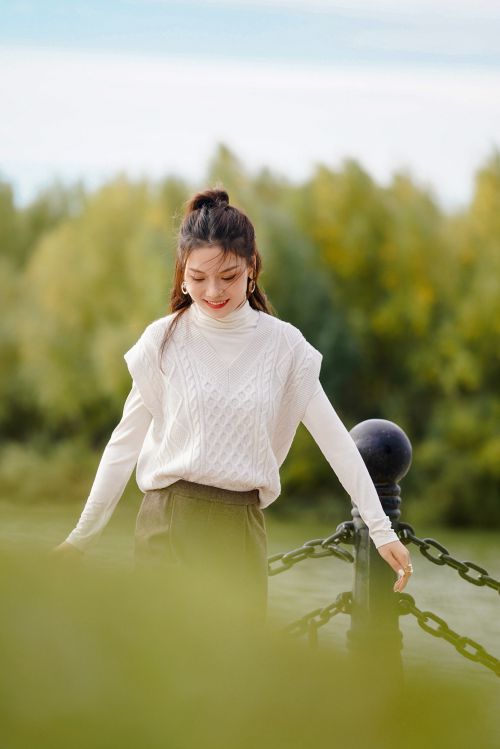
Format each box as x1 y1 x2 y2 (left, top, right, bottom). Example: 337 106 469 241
184 247 253 318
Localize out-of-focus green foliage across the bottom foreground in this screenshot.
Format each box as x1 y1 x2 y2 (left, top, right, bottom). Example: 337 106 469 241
0 549 500 749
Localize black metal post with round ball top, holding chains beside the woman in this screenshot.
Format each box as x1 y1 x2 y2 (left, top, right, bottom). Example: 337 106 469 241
347 419 412 678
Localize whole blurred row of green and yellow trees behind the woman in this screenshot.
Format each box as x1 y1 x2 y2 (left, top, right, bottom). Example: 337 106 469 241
0 144 500 526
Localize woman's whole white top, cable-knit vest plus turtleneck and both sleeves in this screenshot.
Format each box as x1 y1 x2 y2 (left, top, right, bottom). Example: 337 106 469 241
66 301 398 550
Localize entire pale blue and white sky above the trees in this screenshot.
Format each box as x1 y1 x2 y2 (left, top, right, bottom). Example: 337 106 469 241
0 0 500 210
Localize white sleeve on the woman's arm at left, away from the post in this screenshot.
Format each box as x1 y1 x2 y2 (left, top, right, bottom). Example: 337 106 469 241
66 382 152 551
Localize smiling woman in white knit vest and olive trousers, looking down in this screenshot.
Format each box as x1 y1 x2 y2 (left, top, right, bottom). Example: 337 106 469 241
54 189 412 610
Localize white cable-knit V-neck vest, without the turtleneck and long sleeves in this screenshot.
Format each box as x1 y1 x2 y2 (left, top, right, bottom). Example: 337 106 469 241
124 309 323 507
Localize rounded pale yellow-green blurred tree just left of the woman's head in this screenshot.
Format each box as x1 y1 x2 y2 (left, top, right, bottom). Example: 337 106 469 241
19 177 171 433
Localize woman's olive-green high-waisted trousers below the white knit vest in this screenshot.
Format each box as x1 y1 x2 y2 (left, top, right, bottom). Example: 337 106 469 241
134 479 268 621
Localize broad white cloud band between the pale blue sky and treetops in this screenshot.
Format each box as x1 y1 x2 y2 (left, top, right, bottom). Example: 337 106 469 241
0 48 500 205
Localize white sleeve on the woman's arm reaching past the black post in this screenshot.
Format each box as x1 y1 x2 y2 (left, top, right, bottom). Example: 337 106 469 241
302 380 398 548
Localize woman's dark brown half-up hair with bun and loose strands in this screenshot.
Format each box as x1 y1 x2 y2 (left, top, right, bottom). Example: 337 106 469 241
159 185 275 371
